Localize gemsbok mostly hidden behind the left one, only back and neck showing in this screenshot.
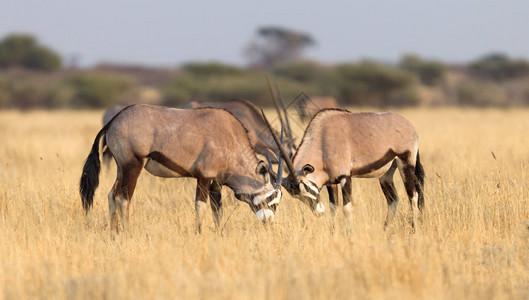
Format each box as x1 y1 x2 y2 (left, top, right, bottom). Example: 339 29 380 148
184 99 294 163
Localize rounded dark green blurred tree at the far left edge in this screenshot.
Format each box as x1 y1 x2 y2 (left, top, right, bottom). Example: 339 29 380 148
0 34 62 71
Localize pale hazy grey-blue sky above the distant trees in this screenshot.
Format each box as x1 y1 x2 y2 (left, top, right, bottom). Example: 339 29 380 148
0 0 529 66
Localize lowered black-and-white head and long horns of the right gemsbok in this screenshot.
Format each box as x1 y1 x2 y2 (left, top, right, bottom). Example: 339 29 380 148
261 110 325 216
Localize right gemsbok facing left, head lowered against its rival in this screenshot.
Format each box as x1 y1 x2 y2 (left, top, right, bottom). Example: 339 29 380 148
264 109 425 228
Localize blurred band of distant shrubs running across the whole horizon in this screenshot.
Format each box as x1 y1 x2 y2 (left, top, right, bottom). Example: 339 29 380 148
0 35 529 109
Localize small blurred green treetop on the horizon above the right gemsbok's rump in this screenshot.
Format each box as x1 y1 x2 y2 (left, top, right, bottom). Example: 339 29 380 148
399 54 446 86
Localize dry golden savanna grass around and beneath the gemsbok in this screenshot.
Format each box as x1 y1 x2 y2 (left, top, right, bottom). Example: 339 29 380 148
0 108 529 299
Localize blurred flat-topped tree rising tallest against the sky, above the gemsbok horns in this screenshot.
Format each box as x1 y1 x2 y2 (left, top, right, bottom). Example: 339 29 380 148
245 26 316 69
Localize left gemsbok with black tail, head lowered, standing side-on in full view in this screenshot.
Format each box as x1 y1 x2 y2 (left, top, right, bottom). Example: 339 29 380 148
79 104 282 233
